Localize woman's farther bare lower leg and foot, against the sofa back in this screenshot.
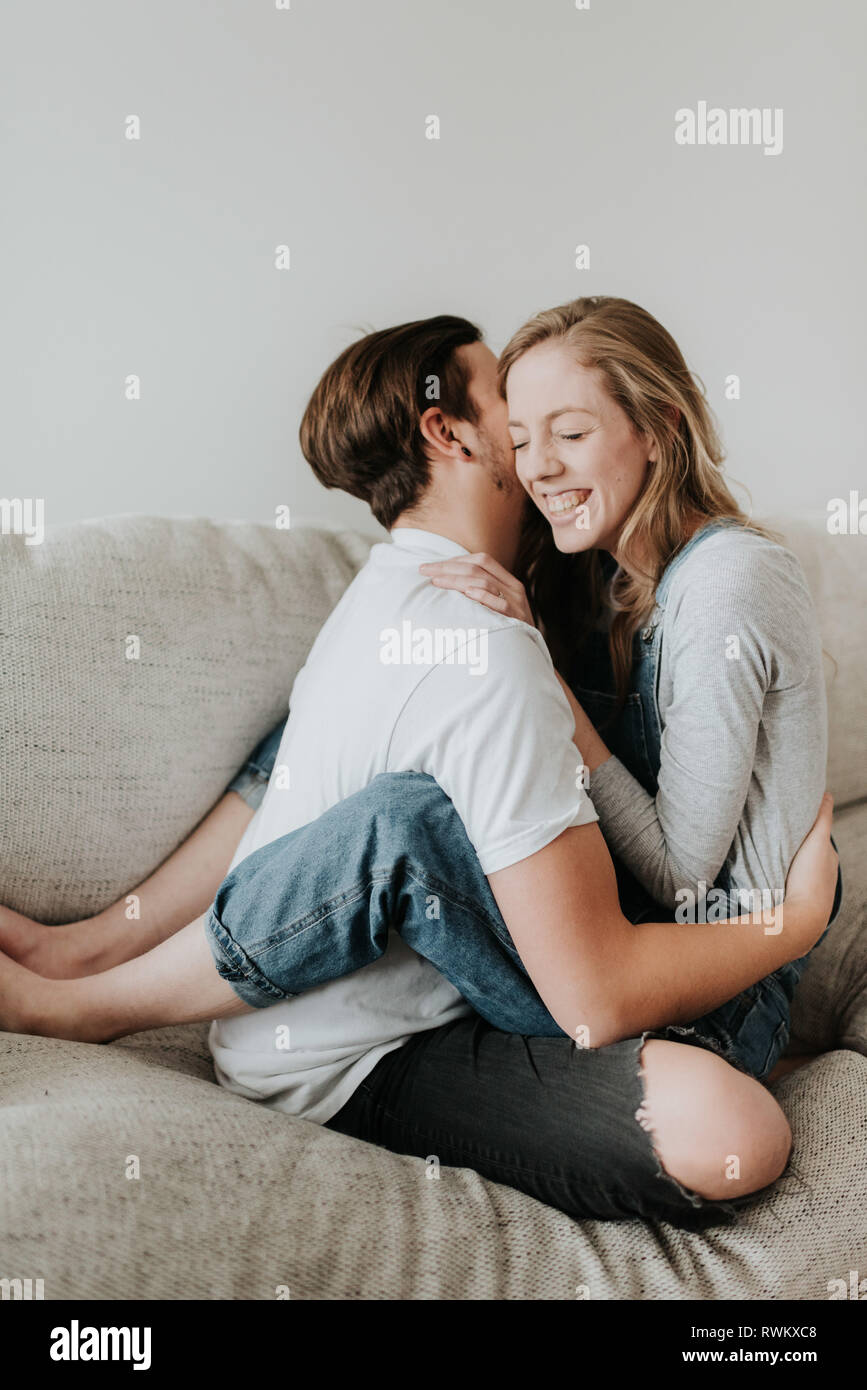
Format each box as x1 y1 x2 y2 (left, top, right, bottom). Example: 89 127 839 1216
0 791 253 980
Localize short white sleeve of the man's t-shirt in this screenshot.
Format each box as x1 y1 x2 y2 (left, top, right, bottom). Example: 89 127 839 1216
388 626 597 874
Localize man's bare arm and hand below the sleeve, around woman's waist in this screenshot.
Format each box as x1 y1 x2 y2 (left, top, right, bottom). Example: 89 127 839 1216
489 796 836 1047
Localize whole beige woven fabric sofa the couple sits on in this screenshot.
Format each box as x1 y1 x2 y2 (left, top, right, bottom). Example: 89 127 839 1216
0 517 867 1300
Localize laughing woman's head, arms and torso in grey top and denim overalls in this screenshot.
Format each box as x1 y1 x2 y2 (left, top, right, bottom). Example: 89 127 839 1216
424 297 839 1077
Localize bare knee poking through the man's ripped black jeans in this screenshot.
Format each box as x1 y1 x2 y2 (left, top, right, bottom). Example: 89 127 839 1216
636 1038 792 1201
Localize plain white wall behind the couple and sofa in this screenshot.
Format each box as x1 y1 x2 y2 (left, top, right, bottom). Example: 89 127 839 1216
0 0 867 525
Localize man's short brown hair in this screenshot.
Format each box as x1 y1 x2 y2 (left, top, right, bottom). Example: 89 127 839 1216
300 314 482 527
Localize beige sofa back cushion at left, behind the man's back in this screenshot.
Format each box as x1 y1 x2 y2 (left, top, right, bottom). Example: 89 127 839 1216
0 517 370 922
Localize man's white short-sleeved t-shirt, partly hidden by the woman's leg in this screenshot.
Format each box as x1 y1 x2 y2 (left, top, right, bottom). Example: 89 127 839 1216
210 527 597 1123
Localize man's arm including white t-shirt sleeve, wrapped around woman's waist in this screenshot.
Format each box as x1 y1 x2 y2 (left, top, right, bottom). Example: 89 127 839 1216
390 627 836 1047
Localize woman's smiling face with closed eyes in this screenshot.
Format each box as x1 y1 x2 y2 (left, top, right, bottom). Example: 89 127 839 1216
506 342 656 553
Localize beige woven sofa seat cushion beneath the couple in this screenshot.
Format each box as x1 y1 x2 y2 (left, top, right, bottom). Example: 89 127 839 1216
0 1029 867 1300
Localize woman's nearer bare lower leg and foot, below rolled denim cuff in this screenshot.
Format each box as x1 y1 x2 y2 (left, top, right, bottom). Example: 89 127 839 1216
0 916 251 1043
